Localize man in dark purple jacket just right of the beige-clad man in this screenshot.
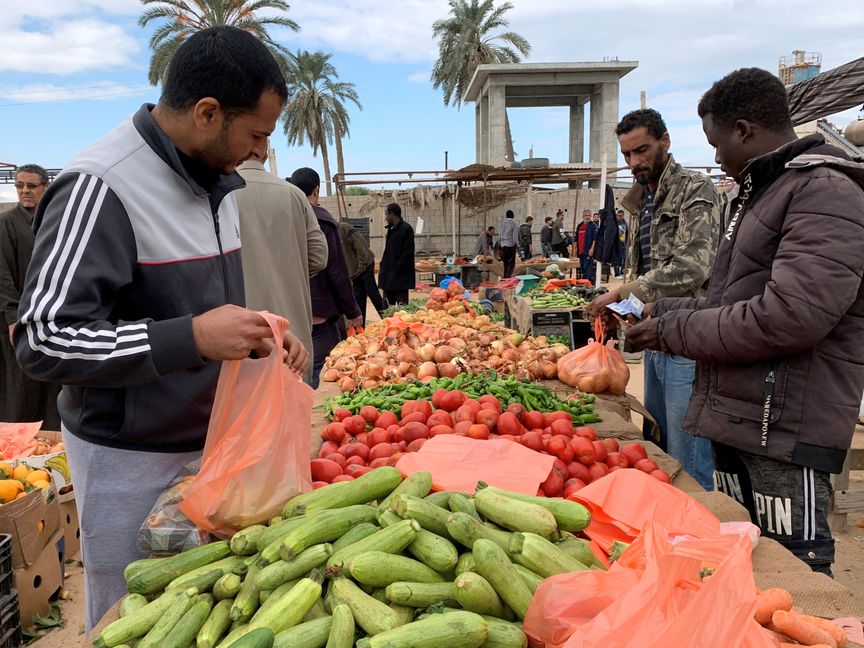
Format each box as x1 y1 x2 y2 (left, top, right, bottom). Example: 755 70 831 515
283 167 363 389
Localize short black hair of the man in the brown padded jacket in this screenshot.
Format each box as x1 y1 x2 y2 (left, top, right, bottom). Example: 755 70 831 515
698 68 792 132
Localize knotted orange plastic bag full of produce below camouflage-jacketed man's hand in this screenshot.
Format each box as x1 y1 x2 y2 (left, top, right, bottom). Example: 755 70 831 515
558 317 630 396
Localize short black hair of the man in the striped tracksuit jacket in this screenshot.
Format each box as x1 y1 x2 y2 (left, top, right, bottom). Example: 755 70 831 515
160 25 288 118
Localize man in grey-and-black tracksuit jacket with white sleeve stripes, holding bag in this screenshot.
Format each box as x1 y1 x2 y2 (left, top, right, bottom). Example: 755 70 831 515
15 27 308 631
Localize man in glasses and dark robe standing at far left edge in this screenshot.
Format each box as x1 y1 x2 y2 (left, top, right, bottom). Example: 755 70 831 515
0 164 60 430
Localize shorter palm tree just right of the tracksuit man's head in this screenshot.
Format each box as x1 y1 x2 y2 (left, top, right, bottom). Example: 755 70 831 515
283 50 363 196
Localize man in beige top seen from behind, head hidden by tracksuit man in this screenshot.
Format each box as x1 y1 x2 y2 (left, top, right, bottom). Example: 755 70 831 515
235 149 328 385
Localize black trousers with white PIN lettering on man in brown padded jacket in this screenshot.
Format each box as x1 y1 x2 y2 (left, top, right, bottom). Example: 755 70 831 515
712 443 834 576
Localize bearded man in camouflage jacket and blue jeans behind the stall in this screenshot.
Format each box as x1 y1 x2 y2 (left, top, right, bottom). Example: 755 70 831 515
589 109 724 490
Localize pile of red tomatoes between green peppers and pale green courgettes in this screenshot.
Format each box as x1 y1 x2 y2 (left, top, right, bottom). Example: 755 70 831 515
312 389 671 497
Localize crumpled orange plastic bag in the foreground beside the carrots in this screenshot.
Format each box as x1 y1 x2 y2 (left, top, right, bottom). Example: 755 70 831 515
524 522 775 648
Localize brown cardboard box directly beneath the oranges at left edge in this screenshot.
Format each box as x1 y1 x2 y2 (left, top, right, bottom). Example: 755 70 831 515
0 489 60 569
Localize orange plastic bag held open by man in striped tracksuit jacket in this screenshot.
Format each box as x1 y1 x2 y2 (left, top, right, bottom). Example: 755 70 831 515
180 313 314 537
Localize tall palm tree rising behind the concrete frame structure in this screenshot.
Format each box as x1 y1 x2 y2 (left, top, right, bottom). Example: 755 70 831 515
432 0 531 160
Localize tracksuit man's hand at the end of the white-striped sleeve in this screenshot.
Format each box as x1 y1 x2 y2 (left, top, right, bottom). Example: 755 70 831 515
192 304 274 360
